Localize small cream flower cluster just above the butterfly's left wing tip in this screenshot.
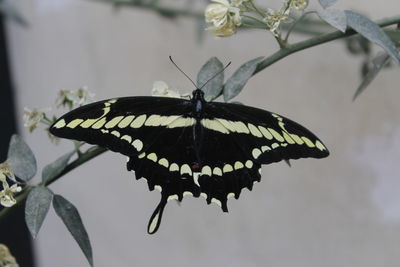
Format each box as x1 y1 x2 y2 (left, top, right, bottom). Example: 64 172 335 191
56 87 94 109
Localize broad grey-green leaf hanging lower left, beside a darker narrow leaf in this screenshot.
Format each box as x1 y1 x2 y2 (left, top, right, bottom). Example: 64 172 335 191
25 186 53 238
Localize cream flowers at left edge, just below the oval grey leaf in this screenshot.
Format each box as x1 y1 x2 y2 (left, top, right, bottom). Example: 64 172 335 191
0 162 22 209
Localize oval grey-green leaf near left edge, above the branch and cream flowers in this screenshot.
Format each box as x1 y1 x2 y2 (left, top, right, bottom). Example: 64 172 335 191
7 134 37 182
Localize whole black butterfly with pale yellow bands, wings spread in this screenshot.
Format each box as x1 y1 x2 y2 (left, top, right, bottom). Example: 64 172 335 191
50 89 329 234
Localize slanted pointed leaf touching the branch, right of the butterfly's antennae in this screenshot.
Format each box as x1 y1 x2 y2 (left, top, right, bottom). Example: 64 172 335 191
224 57 264 102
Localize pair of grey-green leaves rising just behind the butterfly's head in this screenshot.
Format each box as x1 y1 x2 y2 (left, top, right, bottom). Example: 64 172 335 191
197 57 263 102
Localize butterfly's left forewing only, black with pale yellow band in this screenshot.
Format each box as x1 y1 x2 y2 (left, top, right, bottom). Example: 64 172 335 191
50 97 190 156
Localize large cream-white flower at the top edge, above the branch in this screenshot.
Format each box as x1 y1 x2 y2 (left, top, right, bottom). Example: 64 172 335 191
205 0 242 37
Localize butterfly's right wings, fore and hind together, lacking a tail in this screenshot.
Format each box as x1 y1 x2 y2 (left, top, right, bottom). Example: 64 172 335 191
192 102 329 215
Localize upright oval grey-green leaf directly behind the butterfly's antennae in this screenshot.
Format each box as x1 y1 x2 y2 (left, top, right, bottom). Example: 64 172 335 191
197 57 224 101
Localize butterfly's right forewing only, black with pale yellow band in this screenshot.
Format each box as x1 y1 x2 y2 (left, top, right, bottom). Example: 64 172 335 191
203 103 329 164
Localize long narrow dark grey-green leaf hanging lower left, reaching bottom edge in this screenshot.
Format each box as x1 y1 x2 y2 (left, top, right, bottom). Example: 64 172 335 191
53 195 93 266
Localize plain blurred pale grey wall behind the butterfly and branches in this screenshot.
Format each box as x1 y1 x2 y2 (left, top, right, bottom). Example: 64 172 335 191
0 0 400 267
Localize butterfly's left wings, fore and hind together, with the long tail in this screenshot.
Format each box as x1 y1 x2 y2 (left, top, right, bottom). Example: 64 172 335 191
50 97 200 233
